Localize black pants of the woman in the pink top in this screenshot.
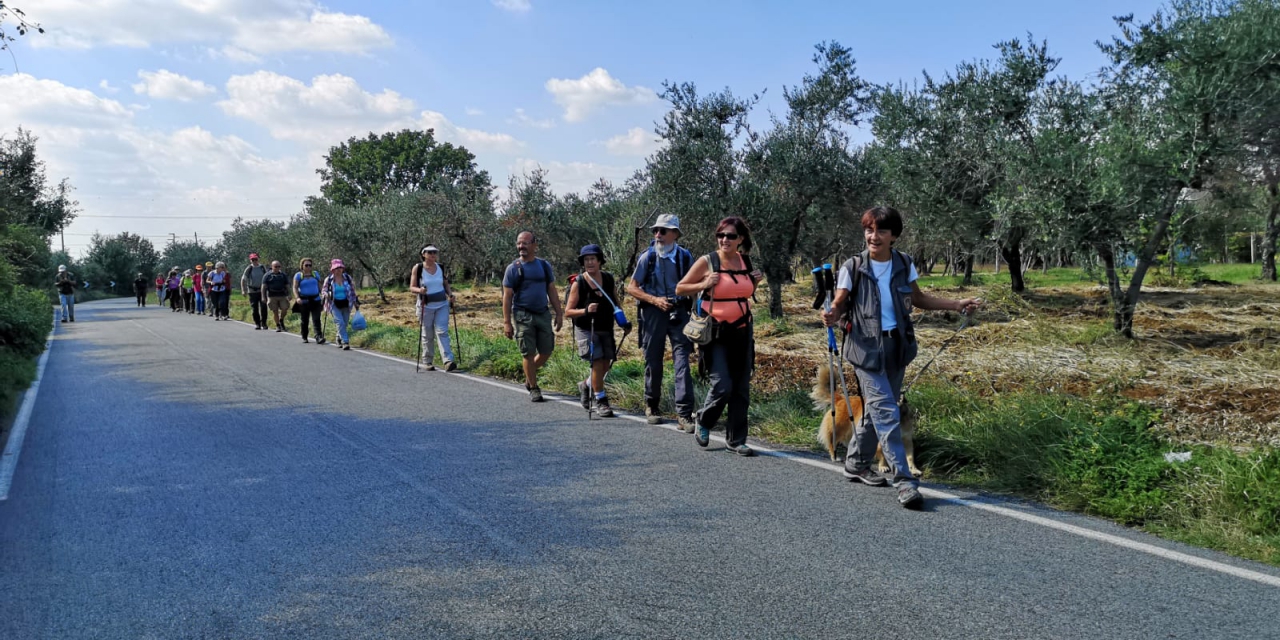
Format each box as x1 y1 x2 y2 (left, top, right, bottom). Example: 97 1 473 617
698 325 755 447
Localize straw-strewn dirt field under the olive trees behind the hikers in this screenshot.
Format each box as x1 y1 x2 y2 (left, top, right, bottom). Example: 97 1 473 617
366 284 1280 447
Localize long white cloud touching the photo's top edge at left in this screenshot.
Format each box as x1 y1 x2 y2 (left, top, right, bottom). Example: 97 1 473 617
27 0 392 55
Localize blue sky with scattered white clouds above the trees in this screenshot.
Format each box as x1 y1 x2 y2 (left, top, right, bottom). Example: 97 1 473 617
0 0 1160 252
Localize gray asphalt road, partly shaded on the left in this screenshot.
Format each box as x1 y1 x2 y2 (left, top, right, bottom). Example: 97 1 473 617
0 300 1280 640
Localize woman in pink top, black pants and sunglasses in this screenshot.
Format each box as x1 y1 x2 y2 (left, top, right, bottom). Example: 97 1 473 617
676 216 763 456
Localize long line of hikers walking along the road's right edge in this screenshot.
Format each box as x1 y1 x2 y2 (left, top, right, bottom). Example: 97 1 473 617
59 206 980 508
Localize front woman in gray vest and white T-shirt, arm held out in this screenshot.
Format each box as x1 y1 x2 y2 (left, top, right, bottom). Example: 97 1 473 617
822 206 982 508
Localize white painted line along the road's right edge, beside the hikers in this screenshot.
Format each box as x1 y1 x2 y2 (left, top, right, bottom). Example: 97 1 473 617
345 332 1280 588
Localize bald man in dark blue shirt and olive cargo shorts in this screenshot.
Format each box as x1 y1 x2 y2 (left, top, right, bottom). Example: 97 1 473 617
502 232 564 402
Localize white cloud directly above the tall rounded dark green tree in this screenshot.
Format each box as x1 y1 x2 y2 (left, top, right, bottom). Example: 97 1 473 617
218 72 524 154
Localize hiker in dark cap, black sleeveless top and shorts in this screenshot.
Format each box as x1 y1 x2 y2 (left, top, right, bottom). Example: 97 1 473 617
564 244 618 417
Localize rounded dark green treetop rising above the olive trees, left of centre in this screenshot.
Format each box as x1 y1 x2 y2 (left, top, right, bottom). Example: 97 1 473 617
316 129 490 206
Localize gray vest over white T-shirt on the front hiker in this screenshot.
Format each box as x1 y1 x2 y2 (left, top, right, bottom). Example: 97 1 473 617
841 250 919 371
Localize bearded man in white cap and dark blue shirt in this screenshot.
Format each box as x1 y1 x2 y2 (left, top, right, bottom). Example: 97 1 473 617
624 214 696 433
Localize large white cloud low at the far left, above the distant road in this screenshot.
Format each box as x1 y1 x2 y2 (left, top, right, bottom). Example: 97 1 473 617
0 74 319 253
